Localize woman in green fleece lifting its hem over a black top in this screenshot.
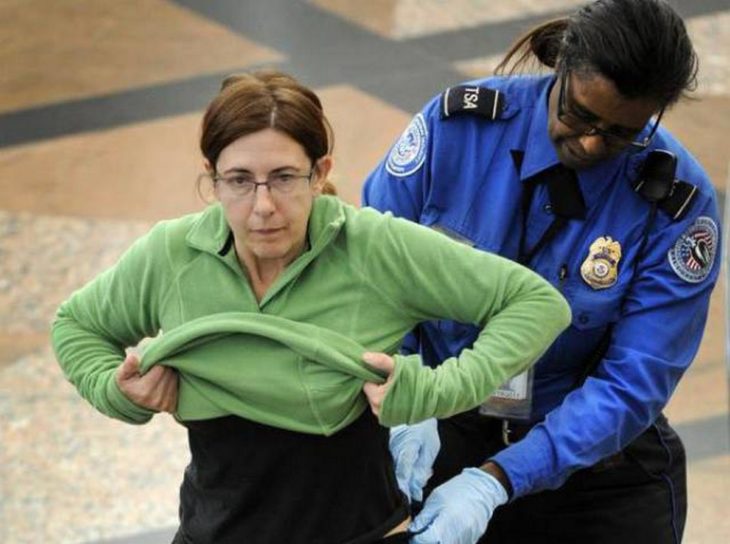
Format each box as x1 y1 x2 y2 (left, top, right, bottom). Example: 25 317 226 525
53 72 570 544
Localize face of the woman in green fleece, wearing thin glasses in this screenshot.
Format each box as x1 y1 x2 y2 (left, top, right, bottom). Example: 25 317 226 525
215 128 331 268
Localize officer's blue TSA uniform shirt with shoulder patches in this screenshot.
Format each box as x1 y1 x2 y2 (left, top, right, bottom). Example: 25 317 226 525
363 76 720 497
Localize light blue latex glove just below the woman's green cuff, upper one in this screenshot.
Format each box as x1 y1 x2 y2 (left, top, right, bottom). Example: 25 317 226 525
390 419 441 502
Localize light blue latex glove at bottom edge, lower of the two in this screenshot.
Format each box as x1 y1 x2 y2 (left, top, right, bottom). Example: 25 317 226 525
408 468 508 544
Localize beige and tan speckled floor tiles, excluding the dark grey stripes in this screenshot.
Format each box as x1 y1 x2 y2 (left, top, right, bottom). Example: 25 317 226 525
0 0 730 544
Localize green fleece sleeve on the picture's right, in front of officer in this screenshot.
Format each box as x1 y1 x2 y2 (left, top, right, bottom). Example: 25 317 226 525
366 210 571 426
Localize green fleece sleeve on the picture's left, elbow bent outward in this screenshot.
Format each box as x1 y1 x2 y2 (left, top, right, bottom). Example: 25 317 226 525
51 222 169 423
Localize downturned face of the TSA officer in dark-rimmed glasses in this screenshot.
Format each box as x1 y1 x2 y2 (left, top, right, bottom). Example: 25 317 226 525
548 71 660 170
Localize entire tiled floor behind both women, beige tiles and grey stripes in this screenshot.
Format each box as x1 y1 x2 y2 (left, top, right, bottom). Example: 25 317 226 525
0 0 730 544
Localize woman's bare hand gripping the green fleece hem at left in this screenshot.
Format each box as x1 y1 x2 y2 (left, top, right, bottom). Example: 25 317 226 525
116 354 178 413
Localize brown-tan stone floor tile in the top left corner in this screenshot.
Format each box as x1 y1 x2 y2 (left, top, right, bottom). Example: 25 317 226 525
0 0 283 112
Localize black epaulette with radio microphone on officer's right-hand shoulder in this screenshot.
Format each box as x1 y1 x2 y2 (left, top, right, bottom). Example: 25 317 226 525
633 149 697 221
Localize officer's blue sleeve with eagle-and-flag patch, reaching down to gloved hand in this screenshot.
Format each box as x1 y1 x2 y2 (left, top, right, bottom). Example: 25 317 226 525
486 191 720 497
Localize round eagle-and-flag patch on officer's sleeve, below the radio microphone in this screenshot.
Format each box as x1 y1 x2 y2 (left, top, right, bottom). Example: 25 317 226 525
667 216 718 283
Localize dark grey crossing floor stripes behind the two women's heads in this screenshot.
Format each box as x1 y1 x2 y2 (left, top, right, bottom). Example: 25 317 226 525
7 0 730 148
